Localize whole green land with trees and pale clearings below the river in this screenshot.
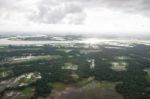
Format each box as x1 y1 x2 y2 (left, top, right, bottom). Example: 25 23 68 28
0 44 150 99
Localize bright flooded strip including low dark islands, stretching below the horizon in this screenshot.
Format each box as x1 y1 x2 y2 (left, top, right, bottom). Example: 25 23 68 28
0 35 150 47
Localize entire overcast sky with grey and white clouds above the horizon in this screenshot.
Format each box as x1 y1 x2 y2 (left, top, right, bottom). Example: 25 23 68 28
0 0 150 33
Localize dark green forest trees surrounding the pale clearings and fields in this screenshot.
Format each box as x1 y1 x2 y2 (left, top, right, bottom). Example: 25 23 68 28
0 45 150 99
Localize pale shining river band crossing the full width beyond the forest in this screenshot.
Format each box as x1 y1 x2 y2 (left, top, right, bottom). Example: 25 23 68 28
0 38 150 47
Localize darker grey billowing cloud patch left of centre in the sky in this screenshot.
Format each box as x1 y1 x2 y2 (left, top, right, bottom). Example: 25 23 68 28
31 0 85 24
